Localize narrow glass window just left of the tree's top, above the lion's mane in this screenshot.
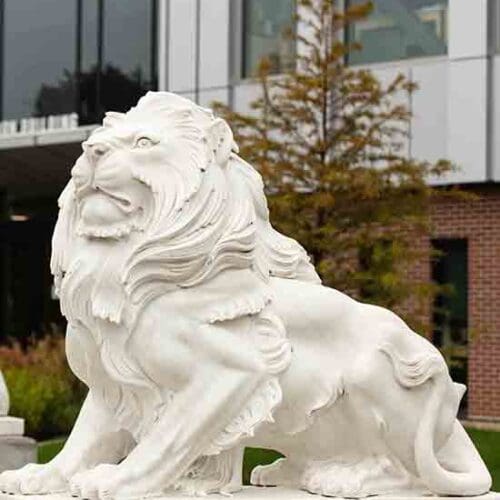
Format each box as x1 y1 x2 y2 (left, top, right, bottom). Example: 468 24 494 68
242 0 295 78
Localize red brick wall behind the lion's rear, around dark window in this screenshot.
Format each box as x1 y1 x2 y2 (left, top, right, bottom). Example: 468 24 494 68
412 186 500 421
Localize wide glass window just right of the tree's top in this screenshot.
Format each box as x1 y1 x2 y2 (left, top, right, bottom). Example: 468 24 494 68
347 0 448 64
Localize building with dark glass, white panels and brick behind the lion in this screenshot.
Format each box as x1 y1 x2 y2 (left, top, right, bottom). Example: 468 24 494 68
0 0 500 420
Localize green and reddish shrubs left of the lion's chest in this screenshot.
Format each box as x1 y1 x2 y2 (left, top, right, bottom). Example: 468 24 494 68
0 335 86 439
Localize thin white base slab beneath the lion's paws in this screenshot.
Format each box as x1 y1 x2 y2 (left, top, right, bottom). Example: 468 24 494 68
0 486 500 500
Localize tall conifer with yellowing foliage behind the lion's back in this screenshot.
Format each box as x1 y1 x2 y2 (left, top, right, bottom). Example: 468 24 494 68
215 0 458 326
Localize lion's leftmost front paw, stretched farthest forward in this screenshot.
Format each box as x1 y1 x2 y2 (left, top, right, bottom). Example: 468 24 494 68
0 464 67 495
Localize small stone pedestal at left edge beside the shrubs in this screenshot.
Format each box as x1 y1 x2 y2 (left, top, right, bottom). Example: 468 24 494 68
0 417 37 472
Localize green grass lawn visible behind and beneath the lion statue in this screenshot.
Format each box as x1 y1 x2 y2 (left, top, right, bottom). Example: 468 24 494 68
38 429 500 491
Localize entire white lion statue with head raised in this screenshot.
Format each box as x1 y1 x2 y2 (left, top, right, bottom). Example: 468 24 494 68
0 92 491 499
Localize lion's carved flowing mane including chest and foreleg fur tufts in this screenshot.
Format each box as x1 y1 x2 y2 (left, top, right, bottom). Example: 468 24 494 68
51 92 320 479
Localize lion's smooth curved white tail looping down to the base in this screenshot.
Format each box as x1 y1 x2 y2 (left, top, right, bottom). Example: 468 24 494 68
415 371 491 496
